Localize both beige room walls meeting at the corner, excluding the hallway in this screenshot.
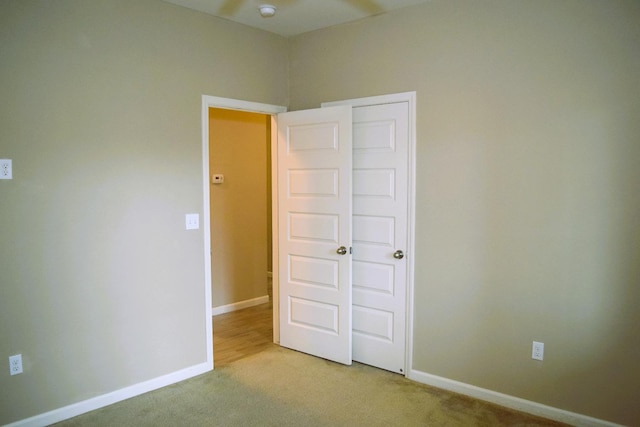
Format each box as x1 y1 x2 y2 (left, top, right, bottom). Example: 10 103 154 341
0 0 640 425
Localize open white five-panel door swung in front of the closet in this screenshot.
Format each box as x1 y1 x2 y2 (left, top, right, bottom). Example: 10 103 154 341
277 106 352 365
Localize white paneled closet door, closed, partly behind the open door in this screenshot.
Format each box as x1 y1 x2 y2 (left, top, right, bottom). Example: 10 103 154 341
352 102 409 373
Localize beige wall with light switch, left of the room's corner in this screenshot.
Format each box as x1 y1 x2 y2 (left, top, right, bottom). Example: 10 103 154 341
0 0 287 424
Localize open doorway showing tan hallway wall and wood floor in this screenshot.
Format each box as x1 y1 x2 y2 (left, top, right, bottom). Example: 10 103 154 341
208 108 273 366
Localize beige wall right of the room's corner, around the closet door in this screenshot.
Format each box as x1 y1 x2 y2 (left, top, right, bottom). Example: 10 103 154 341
289 0 640 425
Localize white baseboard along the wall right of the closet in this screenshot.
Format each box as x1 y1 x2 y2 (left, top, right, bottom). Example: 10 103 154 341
408 369 623 427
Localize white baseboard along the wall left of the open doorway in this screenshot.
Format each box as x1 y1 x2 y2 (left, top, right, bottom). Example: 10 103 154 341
5 362 213 427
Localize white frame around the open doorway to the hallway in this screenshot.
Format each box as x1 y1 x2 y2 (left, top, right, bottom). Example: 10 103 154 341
201 95 287 369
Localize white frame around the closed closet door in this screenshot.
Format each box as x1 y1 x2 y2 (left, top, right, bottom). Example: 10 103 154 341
321 91 416 378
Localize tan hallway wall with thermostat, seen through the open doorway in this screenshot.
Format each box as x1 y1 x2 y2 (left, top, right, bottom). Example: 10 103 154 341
209 108 271 307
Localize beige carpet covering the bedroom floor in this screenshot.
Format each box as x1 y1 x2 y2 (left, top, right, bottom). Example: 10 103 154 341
53 345 563 426
